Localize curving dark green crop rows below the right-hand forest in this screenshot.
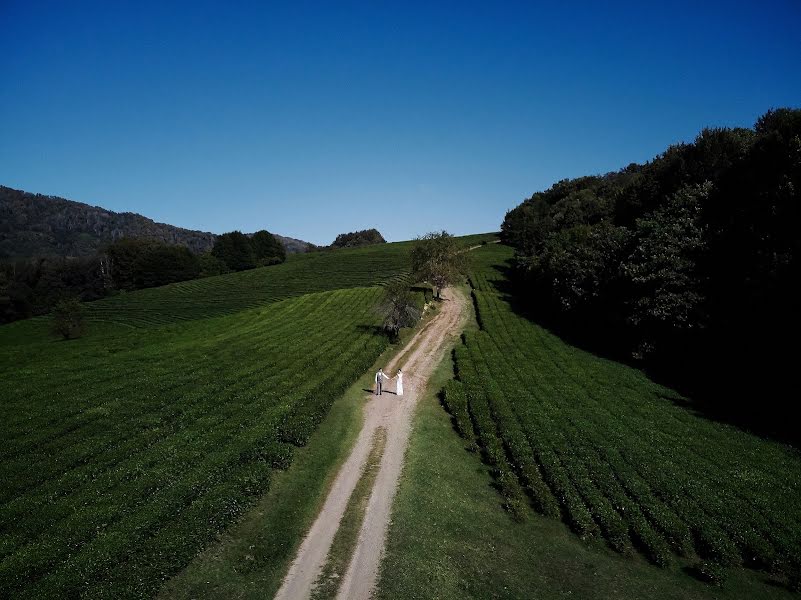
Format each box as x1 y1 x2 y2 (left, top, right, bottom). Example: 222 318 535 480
445 246 801 585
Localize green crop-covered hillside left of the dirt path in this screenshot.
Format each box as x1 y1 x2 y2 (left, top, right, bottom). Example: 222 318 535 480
0 236 494 598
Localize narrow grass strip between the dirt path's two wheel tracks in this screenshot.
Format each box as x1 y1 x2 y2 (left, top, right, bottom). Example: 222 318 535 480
312 427 387 600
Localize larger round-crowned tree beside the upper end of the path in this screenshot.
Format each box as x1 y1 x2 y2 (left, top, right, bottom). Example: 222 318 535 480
412 231 467 298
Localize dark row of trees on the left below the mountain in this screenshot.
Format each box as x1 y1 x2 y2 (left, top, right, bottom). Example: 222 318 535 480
0 231 286 323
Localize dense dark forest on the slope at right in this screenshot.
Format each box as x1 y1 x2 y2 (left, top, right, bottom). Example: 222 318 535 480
501 109 801 439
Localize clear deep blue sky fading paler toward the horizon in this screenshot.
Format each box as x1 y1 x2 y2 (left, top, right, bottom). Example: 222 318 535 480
0 0 801 243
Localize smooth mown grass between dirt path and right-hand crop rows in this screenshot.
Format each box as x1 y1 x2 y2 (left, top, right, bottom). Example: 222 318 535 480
376 352 794 600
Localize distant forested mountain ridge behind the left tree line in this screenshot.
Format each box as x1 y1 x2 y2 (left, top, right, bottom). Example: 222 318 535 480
0 186 309 258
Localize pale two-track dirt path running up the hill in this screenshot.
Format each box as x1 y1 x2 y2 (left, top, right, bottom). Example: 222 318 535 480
275 288 469 600
